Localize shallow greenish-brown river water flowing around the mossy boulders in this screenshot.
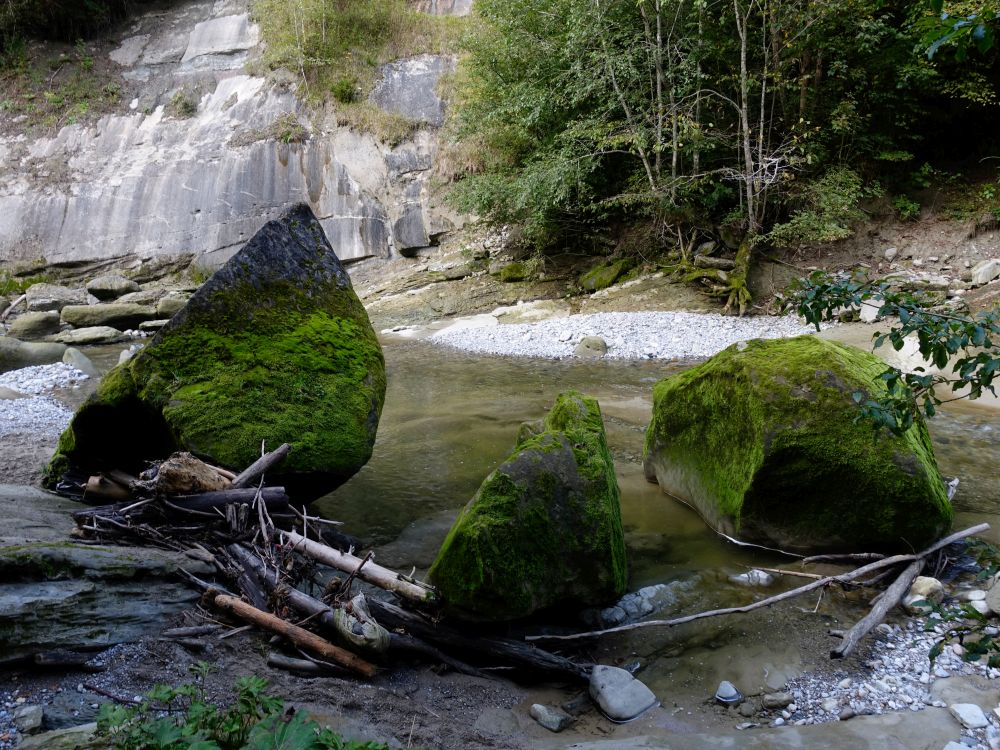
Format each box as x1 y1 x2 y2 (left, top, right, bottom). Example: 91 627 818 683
315 340 1000 588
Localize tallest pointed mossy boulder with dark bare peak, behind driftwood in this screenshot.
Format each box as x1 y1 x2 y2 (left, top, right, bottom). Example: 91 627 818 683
47 205 385 500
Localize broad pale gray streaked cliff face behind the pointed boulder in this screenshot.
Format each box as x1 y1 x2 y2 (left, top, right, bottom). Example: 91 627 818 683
0 0 462 274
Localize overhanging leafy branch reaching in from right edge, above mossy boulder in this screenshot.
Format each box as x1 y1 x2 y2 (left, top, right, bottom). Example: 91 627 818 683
785 271 1000 434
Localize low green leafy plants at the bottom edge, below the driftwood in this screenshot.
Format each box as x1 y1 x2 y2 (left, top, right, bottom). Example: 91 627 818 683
97 669 388 750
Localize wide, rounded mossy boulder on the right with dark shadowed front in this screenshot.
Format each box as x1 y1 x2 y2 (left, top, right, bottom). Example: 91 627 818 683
644 336 952 553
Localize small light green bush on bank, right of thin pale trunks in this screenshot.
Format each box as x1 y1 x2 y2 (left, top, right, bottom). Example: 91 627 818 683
765 167 864 247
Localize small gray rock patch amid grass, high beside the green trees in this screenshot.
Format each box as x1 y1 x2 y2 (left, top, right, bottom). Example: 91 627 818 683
371 55 455 126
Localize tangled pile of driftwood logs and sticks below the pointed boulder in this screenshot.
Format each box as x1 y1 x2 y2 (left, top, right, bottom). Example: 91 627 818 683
73 445 591 681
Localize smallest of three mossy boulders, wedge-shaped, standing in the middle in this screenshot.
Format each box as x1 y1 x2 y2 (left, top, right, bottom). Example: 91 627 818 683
429 391 627 622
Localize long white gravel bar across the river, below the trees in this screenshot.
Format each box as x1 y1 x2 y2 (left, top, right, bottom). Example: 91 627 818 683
430 312 815 359
